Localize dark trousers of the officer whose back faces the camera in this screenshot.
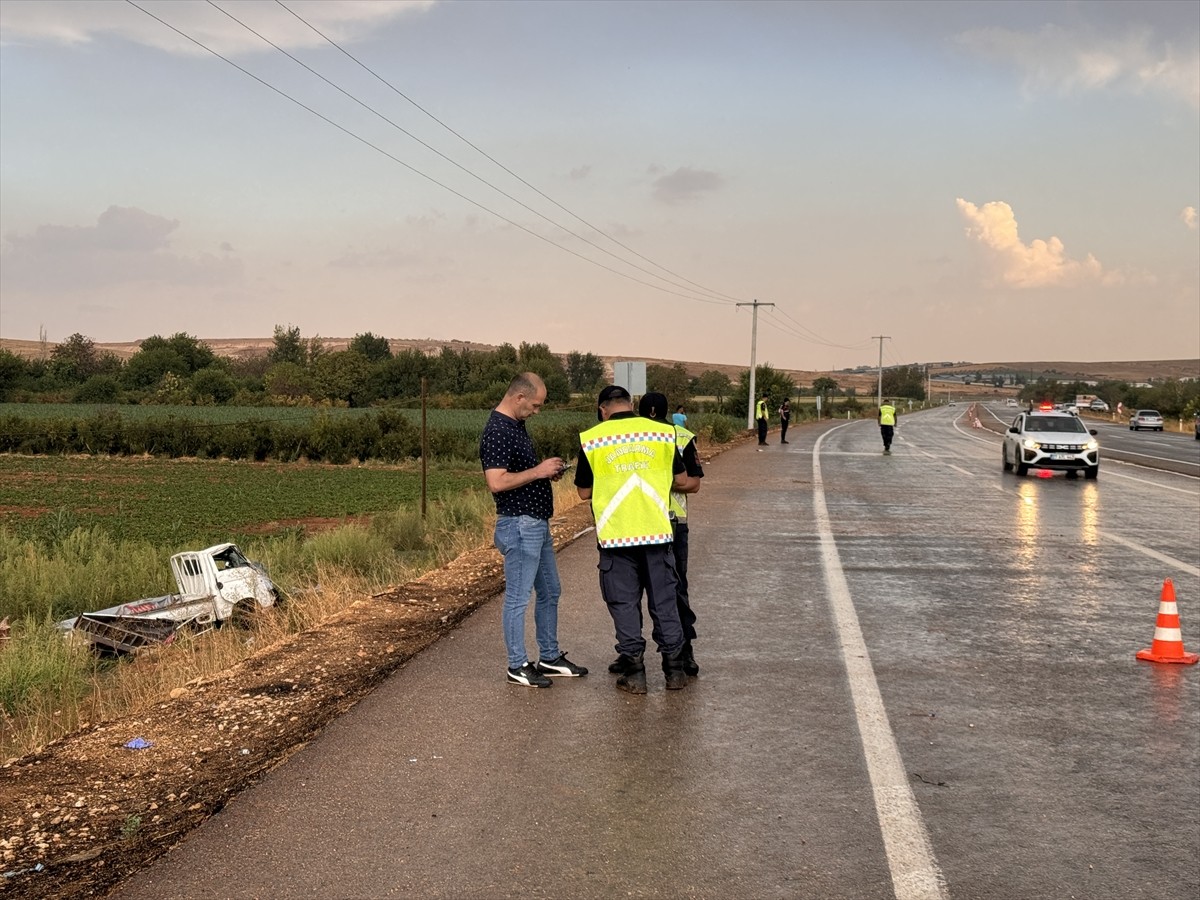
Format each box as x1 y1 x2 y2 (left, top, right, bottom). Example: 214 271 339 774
599 544 684 656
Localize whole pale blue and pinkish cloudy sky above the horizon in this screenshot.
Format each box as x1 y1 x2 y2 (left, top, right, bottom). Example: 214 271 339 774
0 0 1200 370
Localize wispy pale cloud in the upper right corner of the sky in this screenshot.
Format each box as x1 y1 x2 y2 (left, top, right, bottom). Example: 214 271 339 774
955 25 1200 109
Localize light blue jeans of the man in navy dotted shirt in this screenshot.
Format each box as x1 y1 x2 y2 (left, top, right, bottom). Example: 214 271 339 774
494 516 563 668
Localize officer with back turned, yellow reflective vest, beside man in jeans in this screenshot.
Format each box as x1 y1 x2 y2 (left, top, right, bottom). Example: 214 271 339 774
575 384 688 694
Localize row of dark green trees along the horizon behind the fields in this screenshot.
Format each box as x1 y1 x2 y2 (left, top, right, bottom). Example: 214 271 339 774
0 325 907 416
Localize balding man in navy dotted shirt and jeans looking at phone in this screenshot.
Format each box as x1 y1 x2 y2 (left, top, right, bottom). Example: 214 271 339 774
479 372 588 688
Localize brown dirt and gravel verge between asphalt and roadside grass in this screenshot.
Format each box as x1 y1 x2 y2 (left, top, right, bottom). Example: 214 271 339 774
0 504 580 898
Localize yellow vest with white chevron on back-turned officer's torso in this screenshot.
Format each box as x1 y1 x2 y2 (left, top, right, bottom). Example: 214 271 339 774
580 416 676 548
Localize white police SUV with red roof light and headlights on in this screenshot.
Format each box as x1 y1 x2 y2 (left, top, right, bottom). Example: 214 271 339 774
1001 403 1100 478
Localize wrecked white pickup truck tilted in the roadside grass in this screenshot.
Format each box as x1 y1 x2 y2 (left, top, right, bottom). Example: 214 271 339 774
59 544 278 653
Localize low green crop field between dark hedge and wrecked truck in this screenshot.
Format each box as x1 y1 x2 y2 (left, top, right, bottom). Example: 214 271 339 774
0 456 486 548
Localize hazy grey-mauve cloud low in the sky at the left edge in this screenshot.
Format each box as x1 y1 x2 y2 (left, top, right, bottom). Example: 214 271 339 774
0 206 242 290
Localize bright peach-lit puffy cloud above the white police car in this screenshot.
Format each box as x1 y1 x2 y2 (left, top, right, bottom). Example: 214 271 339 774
955 197 1124 288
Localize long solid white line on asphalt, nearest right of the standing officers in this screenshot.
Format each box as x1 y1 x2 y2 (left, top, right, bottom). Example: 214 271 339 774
812 425 949 900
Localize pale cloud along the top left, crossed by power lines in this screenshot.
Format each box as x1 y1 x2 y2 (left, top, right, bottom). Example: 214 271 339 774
0 0 437 56
